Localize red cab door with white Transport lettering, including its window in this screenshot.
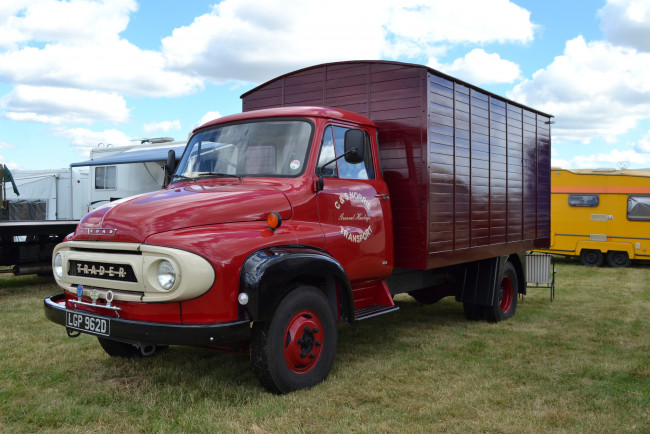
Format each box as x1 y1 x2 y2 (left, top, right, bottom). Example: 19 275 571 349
317 125 393 282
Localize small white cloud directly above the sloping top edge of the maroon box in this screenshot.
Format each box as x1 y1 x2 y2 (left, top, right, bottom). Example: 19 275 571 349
429 48 521 85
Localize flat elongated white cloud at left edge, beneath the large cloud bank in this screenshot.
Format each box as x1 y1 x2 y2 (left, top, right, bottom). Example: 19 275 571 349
0 86 129 125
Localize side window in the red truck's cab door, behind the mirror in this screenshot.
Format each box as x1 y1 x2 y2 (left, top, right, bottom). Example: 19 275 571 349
318 126 375 179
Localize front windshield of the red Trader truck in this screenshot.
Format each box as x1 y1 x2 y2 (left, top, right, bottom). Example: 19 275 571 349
172 120 313 182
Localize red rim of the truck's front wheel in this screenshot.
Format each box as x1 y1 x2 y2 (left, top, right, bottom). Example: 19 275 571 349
283 310 324 374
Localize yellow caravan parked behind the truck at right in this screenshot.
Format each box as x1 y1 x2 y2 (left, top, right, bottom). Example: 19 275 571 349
541 169 650 267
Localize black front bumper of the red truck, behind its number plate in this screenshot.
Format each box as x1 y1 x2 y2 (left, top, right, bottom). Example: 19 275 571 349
43 294 250 346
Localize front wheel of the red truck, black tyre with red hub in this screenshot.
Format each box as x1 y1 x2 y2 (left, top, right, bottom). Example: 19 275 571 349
251 286 337 394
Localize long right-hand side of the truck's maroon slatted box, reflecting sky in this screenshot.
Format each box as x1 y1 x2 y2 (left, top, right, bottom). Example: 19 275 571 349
428 70 550 267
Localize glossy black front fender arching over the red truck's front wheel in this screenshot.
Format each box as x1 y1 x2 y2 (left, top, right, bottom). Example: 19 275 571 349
239 246 354 322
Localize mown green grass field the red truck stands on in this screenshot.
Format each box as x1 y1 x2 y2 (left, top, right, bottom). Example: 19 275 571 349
0 259 650 433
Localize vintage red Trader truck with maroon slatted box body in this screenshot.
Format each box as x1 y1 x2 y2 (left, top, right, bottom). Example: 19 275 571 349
44 61 551 393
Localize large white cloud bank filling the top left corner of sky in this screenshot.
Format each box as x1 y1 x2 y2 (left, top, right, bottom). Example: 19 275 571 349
0 0 203 101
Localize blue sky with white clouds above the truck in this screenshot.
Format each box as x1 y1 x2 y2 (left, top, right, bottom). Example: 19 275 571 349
0 0 650 170
